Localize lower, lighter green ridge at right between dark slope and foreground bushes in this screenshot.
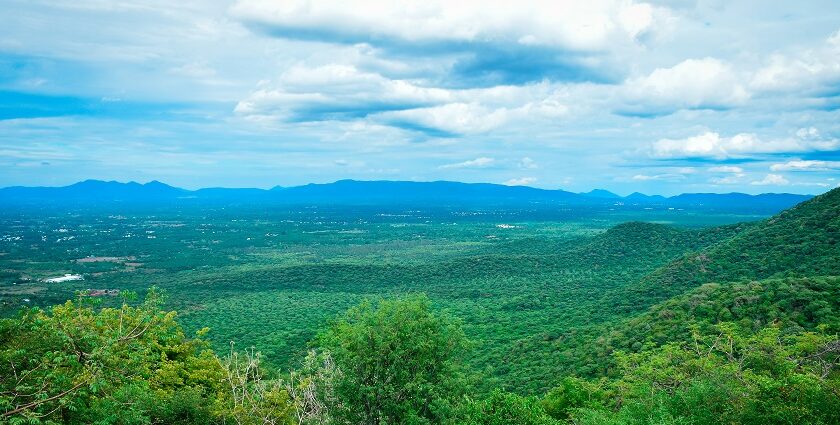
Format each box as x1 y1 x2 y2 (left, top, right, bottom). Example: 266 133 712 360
591 277 840 371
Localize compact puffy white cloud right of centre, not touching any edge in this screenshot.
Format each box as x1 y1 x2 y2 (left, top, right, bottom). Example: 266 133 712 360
617 57 750 115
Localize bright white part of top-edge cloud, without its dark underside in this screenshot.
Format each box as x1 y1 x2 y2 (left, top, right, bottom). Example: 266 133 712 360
232 0 670 50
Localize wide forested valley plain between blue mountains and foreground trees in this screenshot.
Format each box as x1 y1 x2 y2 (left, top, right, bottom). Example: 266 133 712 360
0 205 758 394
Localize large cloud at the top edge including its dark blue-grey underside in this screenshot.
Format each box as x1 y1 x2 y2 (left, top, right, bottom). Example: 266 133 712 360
231 0 676 87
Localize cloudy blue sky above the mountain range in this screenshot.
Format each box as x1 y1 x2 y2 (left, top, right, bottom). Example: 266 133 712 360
0 0 840 195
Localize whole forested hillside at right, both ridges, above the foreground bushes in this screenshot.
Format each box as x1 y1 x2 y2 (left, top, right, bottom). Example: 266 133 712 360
573 189 840 375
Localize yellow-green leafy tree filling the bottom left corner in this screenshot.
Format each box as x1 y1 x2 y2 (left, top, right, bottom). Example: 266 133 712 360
0 289 222 423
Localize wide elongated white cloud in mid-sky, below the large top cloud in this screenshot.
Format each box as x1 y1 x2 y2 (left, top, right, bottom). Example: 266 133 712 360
235 64 568 136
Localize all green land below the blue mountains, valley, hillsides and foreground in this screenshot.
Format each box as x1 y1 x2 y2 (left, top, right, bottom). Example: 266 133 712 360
0 189 840 424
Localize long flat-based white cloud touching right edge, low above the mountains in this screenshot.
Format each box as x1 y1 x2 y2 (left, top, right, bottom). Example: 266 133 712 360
651 127 840 159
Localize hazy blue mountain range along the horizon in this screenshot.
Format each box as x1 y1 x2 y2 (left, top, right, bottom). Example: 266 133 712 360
0 180 812 212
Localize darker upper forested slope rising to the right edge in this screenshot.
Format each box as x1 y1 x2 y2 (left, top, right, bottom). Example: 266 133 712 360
618 189 840 310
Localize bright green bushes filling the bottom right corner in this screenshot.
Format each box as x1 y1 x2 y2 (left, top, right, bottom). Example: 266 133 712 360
572 324 840 424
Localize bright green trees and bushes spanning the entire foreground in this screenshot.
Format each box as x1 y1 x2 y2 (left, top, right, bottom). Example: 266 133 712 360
0 290 840 424
